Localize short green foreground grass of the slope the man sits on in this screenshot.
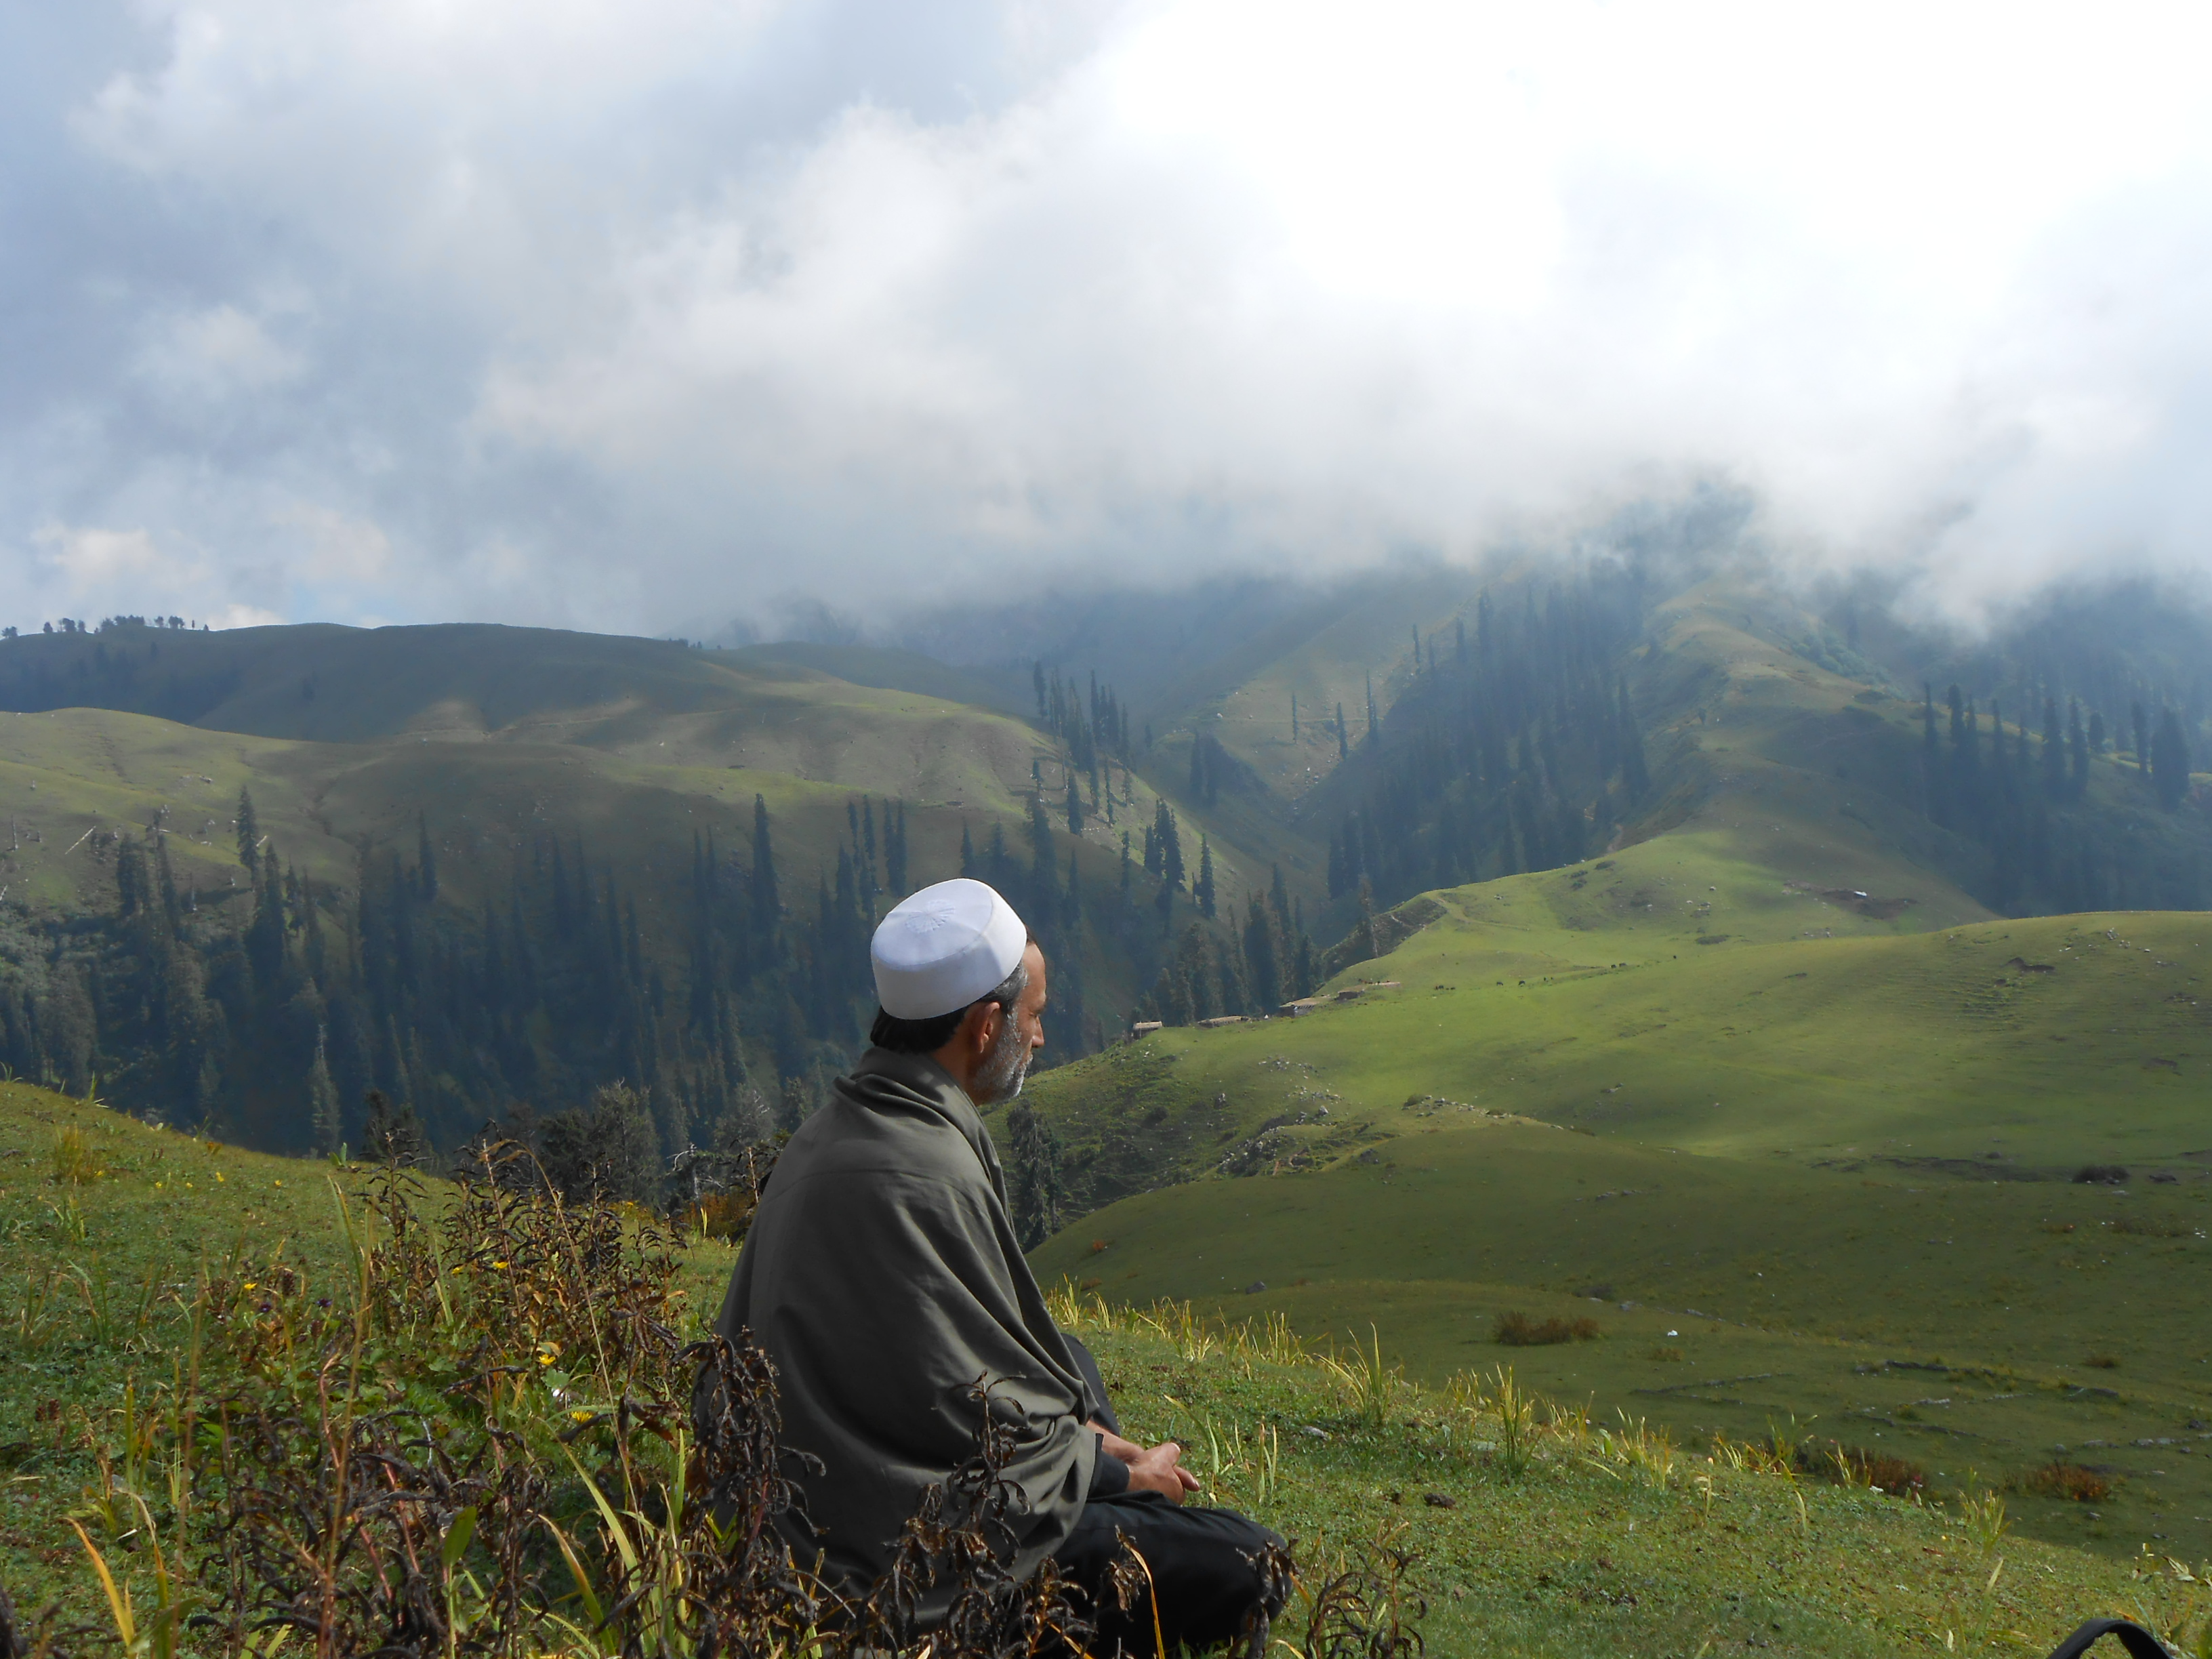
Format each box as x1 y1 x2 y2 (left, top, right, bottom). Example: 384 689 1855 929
0 1086 2212 1659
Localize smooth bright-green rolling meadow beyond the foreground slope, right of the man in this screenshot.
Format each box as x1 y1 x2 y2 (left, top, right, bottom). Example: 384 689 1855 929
1012 872 2212 1574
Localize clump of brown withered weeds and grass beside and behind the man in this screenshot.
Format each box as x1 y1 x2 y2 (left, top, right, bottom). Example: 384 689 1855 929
64 1143 1212 1659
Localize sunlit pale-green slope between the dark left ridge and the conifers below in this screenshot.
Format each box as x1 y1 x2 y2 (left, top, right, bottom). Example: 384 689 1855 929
0 699 1070 942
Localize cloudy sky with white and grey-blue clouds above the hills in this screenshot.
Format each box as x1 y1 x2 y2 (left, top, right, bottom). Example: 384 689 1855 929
0 0 2212 635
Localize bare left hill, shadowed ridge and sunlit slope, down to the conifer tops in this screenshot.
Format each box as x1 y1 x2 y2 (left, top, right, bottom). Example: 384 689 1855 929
0 623 1281 960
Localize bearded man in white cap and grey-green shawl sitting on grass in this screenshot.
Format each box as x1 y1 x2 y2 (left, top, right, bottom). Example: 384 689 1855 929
690 880 1281 1654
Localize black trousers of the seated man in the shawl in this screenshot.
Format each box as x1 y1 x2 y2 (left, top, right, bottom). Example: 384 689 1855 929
1053 1336 1283 1657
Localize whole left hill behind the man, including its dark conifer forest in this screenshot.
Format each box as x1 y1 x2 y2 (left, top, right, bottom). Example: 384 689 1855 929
0 626 1300 1150
